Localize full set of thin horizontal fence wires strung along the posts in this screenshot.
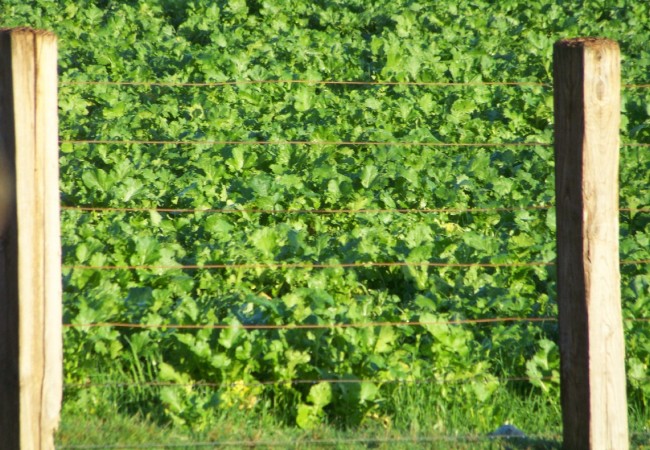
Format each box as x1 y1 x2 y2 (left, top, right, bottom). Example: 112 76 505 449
55 72 650 449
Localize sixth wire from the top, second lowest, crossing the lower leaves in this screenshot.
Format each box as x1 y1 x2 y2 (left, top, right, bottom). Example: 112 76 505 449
63 374 554 389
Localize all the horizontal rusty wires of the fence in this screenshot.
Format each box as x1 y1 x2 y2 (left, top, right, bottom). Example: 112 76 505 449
59 72 650 449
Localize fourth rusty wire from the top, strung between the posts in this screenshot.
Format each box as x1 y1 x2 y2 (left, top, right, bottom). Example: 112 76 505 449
61 261 556 270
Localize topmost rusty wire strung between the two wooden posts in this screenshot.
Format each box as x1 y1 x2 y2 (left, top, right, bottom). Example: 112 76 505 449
59 80 548 87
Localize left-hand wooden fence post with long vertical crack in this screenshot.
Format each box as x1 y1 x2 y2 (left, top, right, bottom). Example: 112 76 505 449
0 28 63 450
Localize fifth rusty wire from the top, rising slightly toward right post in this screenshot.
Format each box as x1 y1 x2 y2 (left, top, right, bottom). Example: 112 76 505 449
63 317 557 330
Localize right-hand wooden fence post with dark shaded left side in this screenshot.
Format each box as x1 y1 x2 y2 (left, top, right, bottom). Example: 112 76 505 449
553 38 628 450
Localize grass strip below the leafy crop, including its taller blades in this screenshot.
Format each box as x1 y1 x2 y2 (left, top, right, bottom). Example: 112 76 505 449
56 385 650 450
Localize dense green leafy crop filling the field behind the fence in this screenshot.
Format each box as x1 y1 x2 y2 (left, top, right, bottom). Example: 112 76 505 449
0 0 650 438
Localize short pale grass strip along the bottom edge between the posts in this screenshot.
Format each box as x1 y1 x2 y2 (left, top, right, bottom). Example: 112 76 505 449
57 415 559 449
